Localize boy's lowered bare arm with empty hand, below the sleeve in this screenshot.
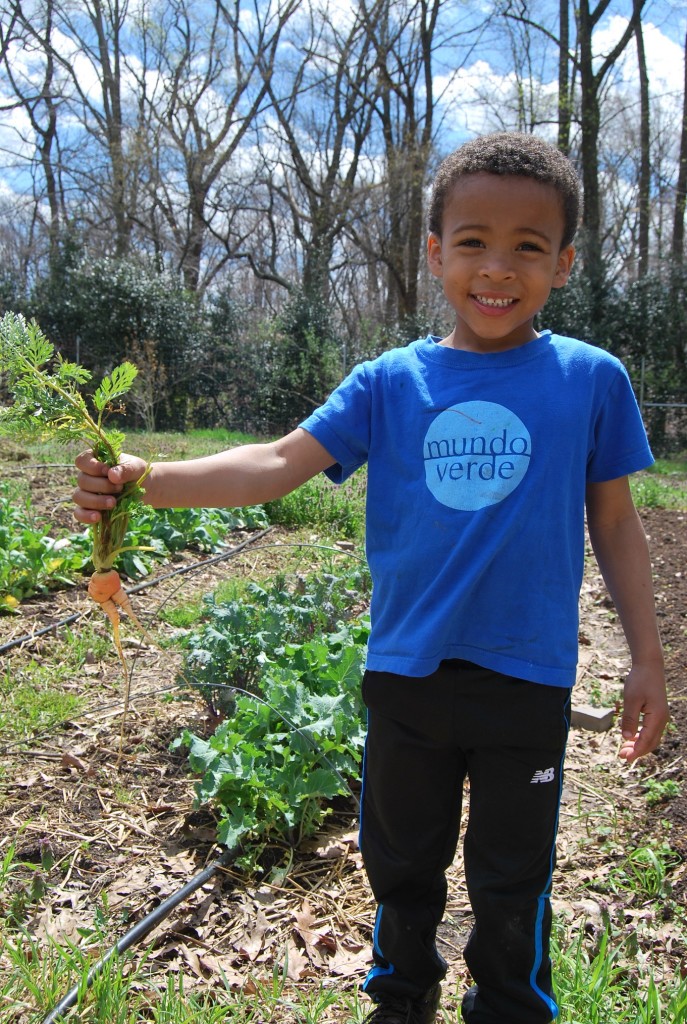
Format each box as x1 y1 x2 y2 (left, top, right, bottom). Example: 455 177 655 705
587 476 670 761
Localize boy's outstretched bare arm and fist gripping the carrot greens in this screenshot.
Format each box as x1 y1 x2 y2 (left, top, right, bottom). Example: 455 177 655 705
73 427 335 524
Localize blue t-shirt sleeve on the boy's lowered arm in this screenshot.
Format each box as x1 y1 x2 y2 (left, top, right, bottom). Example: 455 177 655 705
587 364 654 483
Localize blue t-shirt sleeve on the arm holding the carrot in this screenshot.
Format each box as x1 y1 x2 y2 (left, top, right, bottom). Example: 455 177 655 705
300 364 372 483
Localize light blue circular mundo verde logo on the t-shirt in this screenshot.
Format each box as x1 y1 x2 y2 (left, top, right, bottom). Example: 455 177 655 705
423 401 531 512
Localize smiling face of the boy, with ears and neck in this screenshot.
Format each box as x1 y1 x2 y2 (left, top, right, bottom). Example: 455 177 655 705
428 173 574 352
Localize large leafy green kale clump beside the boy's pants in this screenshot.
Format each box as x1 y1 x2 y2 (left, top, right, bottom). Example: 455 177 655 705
174 575 368 863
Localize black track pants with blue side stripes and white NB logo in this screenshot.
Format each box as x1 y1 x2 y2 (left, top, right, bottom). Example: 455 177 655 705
360 660 570 1024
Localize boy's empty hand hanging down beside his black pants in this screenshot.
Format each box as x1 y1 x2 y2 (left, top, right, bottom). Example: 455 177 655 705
618 666 670 763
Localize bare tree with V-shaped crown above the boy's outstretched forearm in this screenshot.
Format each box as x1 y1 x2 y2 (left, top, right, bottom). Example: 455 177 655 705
139 0 298 291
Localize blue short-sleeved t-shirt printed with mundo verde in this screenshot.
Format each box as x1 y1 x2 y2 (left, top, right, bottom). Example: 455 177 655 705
301 333 653 686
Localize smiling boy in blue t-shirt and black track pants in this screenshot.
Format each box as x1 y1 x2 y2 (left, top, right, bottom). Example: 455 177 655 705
75 133 668 1024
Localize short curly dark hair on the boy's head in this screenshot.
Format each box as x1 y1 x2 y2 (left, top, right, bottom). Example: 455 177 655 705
428 131 582 249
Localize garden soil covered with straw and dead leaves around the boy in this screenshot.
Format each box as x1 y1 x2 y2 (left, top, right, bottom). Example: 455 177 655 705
0 468 687 1024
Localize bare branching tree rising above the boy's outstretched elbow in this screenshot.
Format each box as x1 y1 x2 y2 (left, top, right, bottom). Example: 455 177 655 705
244 0 377 300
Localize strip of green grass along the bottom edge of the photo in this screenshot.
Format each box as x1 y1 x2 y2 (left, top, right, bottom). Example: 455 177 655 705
0 929 687 1024
